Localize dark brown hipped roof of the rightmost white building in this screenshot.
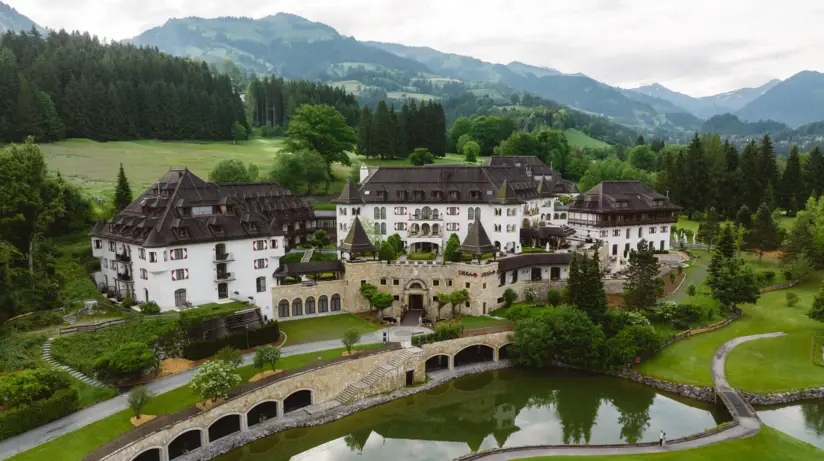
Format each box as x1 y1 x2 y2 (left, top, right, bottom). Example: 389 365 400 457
569 181 681 213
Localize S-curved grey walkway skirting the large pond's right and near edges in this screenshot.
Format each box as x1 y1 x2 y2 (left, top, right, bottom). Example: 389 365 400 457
456 333 784 461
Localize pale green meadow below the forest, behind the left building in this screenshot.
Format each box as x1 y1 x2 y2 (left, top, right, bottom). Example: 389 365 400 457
40 139 283 197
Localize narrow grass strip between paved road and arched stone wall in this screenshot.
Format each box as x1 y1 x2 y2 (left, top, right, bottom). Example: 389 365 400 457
9 344 382 461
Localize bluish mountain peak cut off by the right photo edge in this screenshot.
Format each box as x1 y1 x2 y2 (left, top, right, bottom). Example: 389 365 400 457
735 71 824 128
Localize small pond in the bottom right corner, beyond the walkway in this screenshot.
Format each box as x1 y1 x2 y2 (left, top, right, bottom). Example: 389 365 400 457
758 400 824 448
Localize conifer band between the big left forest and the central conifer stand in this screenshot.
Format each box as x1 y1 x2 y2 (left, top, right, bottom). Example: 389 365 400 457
245 75 360 129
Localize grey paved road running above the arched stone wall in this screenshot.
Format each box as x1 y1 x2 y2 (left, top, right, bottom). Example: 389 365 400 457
0 327 431 460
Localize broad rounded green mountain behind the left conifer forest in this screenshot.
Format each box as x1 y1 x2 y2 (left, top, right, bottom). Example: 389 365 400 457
132 13 429 79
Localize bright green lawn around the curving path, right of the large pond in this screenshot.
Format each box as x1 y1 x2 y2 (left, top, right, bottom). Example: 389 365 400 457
638 266 824 393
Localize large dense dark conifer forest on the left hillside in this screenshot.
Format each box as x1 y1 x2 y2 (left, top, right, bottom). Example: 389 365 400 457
0 31 246 142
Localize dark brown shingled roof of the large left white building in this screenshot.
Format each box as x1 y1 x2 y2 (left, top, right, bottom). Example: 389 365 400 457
92 168 314 248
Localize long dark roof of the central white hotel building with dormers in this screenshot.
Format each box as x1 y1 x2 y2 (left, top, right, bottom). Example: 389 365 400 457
344 165 539 204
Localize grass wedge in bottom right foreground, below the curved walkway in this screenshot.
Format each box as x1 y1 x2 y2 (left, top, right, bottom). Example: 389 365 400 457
522 426 824 461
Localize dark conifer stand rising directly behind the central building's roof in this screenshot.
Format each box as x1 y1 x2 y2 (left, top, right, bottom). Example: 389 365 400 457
357 100 447 159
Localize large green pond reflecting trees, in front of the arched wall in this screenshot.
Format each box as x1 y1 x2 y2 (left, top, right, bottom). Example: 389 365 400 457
217 368 731 461
